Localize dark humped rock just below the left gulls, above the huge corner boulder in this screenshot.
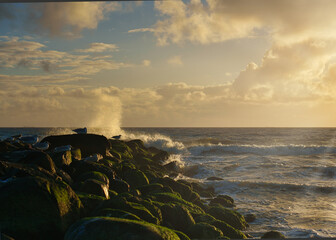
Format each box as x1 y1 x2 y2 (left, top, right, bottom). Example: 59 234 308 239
19 151 56 174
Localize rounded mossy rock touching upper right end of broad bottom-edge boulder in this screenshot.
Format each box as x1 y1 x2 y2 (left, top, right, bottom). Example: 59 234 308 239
160 204 195 233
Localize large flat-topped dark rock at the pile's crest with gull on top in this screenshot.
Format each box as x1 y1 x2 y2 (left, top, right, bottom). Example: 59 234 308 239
42 134 111 157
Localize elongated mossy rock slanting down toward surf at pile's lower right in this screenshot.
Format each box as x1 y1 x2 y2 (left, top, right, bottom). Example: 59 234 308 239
207 206 248 230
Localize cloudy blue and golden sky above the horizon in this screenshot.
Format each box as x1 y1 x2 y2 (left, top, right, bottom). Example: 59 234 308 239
0 0 336 127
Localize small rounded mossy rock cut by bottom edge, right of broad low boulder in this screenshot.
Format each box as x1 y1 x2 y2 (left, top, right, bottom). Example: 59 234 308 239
188 222 223 239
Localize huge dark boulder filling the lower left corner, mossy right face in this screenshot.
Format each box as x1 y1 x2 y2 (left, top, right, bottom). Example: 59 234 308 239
0 177 83 240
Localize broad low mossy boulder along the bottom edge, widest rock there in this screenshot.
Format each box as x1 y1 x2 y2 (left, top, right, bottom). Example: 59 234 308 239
64 217 179 240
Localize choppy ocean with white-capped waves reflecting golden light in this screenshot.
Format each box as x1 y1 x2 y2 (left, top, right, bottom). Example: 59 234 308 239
0 128 336 238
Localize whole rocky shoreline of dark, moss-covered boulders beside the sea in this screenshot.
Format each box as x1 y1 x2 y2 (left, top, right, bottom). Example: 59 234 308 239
0 134 283 240
